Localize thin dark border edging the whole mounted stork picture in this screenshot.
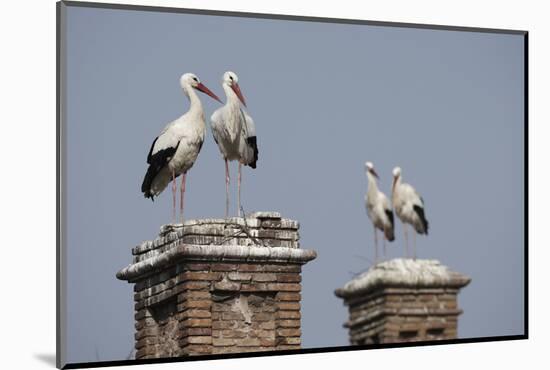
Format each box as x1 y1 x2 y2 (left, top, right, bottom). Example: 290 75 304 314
56 0 529 369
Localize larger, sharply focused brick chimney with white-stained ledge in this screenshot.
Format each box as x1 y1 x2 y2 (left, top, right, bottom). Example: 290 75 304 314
117 212 316 359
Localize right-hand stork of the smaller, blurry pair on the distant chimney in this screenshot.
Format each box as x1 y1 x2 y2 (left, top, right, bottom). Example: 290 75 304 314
392 167 428 259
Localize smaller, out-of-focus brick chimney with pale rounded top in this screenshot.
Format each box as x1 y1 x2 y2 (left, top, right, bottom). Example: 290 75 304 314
335 259 470 345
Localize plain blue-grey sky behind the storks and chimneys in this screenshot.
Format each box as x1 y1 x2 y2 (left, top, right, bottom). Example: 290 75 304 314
67 7 524 362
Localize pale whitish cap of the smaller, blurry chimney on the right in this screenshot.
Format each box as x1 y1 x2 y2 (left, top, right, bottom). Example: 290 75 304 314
335 258 471 298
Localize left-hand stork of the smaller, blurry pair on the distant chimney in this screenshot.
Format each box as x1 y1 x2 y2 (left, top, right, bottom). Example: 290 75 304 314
365 162 395 262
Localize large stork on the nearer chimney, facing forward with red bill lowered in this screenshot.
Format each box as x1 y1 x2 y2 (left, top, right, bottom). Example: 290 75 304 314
210 71 258 217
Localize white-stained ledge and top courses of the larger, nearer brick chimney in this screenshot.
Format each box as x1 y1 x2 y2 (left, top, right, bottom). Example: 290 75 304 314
116 212 317 282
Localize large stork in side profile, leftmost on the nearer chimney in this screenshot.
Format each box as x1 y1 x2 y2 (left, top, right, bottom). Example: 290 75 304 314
141 73 221 223
